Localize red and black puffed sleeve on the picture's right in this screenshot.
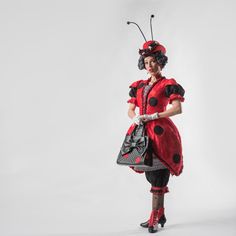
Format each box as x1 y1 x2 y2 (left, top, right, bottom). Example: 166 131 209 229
165 79 185 104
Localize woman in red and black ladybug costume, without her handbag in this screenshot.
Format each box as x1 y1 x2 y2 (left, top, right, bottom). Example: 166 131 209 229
127 40 185 233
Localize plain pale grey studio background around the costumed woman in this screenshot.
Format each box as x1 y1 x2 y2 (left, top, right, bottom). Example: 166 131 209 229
0 0 236 236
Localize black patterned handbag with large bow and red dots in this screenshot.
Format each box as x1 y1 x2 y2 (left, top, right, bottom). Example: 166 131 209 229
116 123 152 167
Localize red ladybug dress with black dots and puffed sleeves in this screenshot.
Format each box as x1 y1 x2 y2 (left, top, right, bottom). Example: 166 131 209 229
127 77 185 176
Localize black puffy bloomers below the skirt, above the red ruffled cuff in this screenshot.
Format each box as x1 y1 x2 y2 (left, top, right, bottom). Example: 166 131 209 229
145 169 170 187
